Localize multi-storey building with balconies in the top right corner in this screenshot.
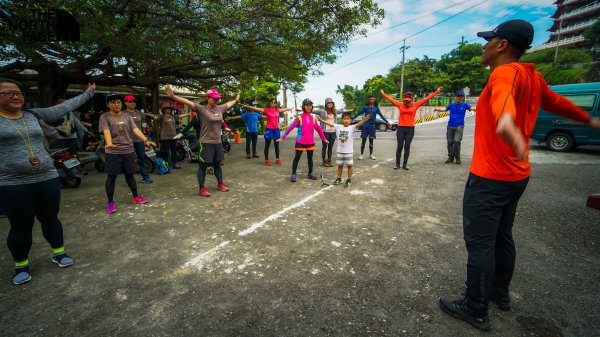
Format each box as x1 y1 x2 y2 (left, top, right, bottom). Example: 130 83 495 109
527 0 600 53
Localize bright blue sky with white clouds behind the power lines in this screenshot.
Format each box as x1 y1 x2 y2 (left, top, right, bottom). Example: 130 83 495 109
278 0 556 108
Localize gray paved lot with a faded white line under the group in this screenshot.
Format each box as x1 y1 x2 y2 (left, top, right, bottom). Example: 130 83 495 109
0 119 600 336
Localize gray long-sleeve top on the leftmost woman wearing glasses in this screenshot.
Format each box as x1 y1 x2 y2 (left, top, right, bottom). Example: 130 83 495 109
0 90 94 186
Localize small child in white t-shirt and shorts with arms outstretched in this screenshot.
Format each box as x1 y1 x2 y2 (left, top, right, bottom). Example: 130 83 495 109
323 112 371 187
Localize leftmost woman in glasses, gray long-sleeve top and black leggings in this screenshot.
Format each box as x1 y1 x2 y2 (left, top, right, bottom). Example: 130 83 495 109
0 78 96 284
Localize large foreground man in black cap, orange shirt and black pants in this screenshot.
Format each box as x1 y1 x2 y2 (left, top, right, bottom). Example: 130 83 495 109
439 20 600 330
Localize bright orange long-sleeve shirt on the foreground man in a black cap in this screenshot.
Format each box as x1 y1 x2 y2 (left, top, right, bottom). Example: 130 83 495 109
471 62 590 181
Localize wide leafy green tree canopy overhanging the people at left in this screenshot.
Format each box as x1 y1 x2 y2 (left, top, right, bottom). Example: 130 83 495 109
0 0 383 103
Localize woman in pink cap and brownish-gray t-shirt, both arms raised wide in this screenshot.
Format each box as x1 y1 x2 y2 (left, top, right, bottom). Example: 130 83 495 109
165 85 240 197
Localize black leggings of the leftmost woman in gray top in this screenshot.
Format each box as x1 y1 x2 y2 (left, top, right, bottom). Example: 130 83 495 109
0 177 64 262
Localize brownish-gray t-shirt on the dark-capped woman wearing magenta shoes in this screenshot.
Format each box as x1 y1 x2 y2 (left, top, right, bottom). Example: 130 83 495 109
99 112 137 154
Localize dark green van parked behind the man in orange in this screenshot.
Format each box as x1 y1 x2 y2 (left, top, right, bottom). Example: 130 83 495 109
531 82 600 152
